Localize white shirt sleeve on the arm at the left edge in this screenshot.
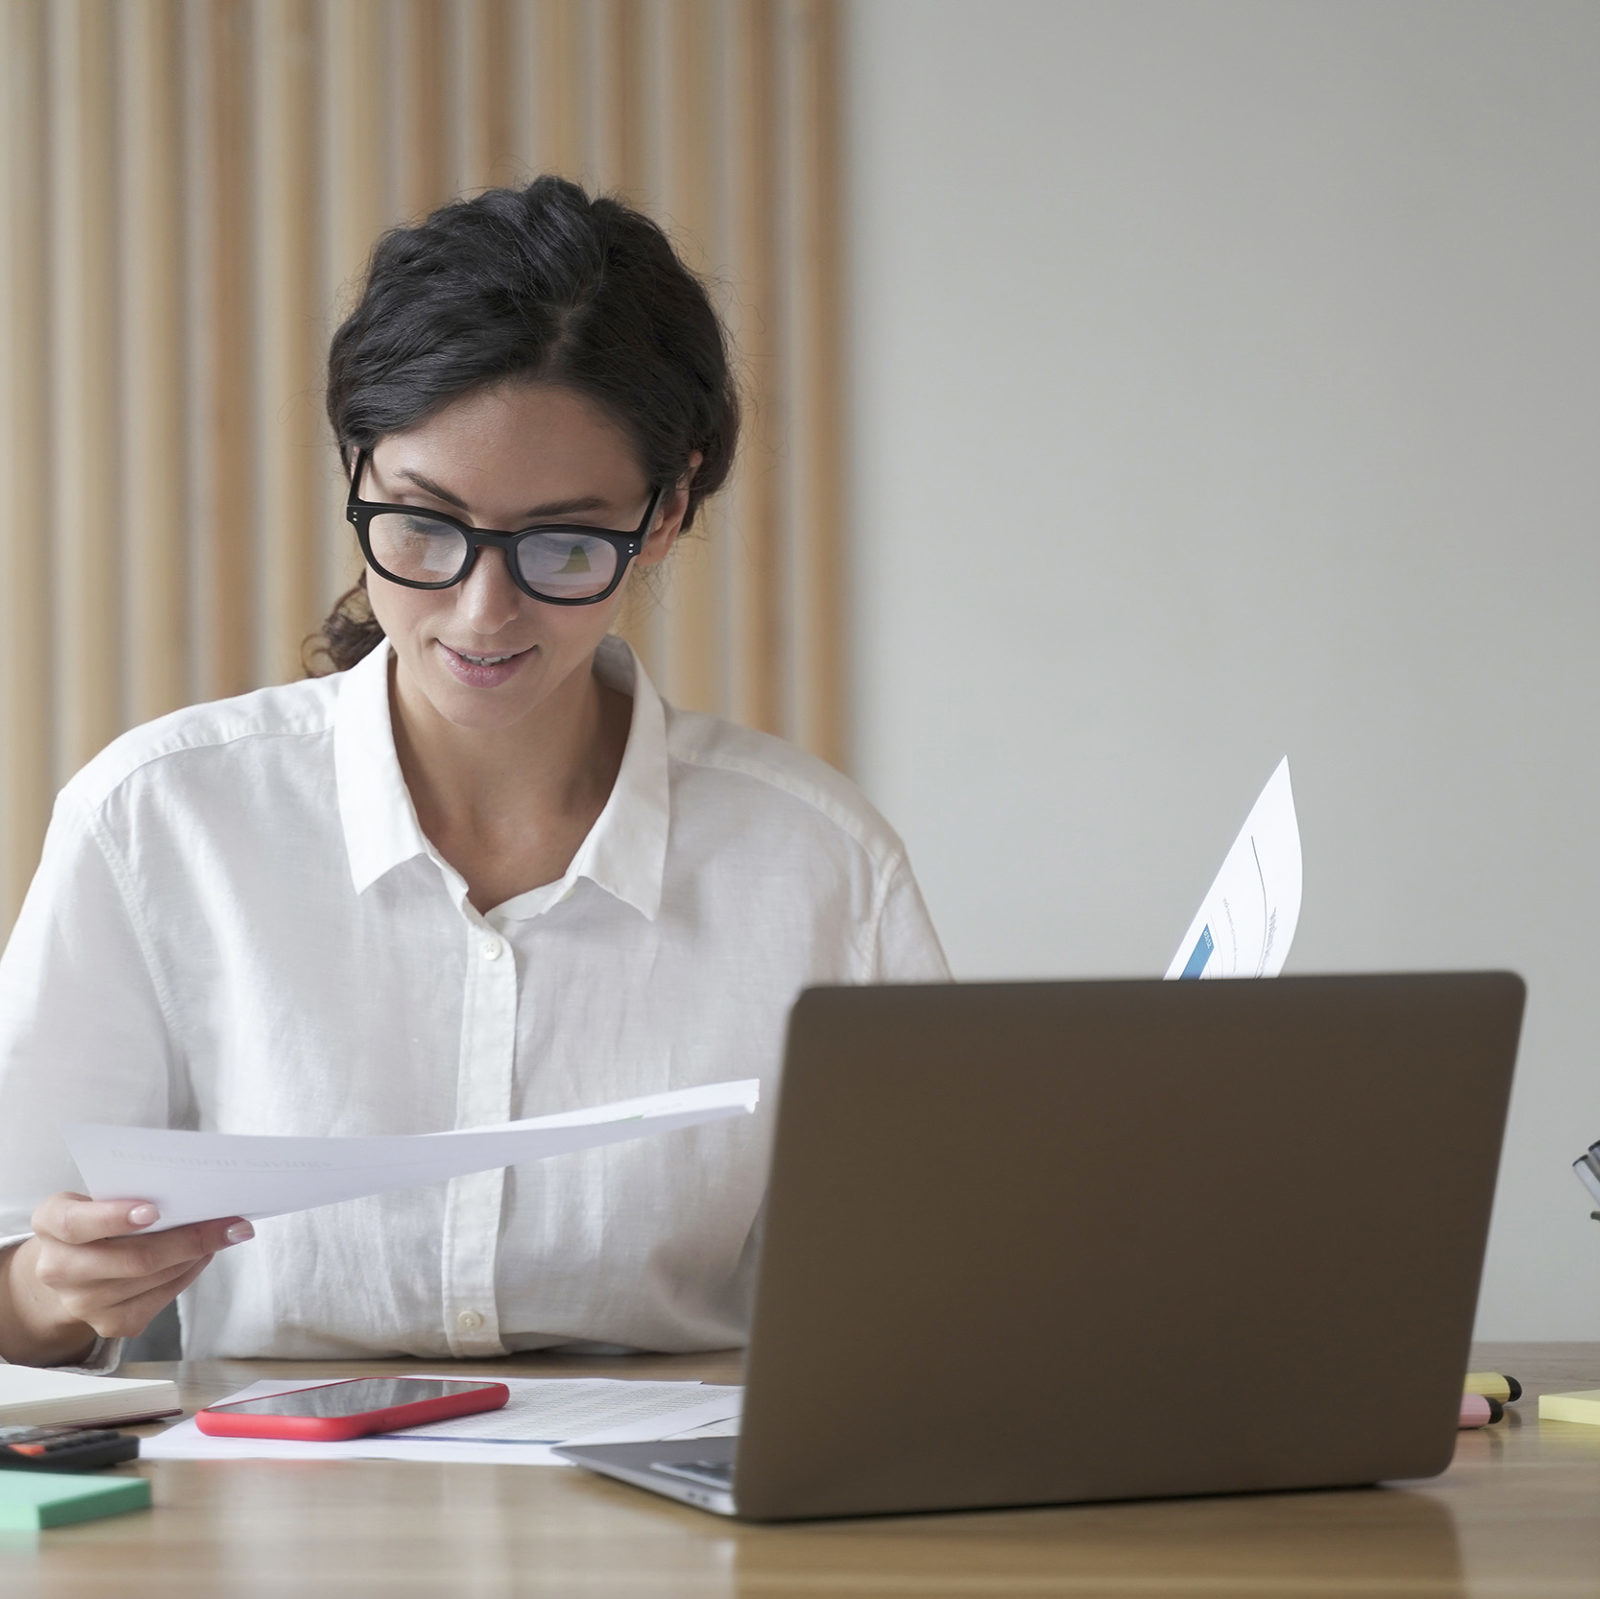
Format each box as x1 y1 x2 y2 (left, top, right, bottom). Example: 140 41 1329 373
0 789 176 1239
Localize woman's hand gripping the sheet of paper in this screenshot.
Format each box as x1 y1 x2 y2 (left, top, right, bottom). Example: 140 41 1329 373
0 1194 256 1365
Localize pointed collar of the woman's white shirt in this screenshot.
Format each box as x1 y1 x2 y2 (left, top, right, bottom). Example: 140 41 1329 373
333 637 670 920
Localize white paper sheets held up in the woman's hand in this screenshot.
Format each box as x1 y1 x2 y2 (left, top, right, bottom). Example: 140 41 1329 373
64 1077 760 1232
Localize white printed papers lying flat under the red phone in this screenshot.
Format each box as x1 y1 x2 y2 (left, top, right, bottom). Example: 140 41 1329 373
139 1372 744 1466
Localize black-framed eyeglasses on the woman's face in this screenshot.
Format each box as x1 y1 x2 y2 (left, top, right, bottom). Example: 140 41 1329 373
344 450 666 605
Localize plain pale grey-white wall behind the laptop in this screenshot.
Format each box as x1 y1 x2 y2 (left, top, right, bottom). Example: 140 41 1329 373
848 0 1600 1338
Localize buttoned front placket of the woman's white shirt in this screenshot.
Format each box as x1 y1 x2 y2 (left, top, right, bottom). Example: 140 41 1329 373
440 911 517 1357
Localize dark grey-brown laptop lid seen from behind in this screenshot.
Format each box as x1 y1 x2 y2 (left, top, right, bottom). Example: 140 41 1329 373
734 973 1525 1519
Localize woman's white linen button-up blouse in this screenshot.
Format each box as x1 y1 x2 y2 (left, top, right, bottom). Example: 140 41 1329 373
0 639 947 1359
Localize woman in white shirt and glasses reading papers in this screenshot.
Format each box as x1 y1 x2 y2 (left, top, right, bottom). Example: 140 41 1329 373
0 178 946 1369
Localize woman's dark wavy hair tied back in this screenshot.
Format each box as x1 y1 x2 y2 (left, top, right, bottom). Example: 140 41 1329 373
307 178 739 671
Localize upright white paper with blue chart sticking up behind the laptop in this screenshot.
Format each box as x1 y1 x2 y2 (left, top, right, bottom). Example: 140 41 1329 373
1166 755 1301 978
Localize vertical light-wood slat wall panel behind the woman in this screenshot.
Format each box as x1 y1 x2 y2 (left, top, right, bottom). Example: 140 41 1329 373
0 0 845 920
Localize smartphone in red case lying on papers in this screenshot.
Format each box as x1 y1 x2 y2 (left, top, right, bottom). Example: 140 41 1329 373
195 1377 510 1444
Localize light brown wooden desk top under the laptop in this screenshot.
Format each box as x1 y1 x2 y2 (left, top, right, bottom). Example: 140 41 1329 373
0 1345 1600 1599
